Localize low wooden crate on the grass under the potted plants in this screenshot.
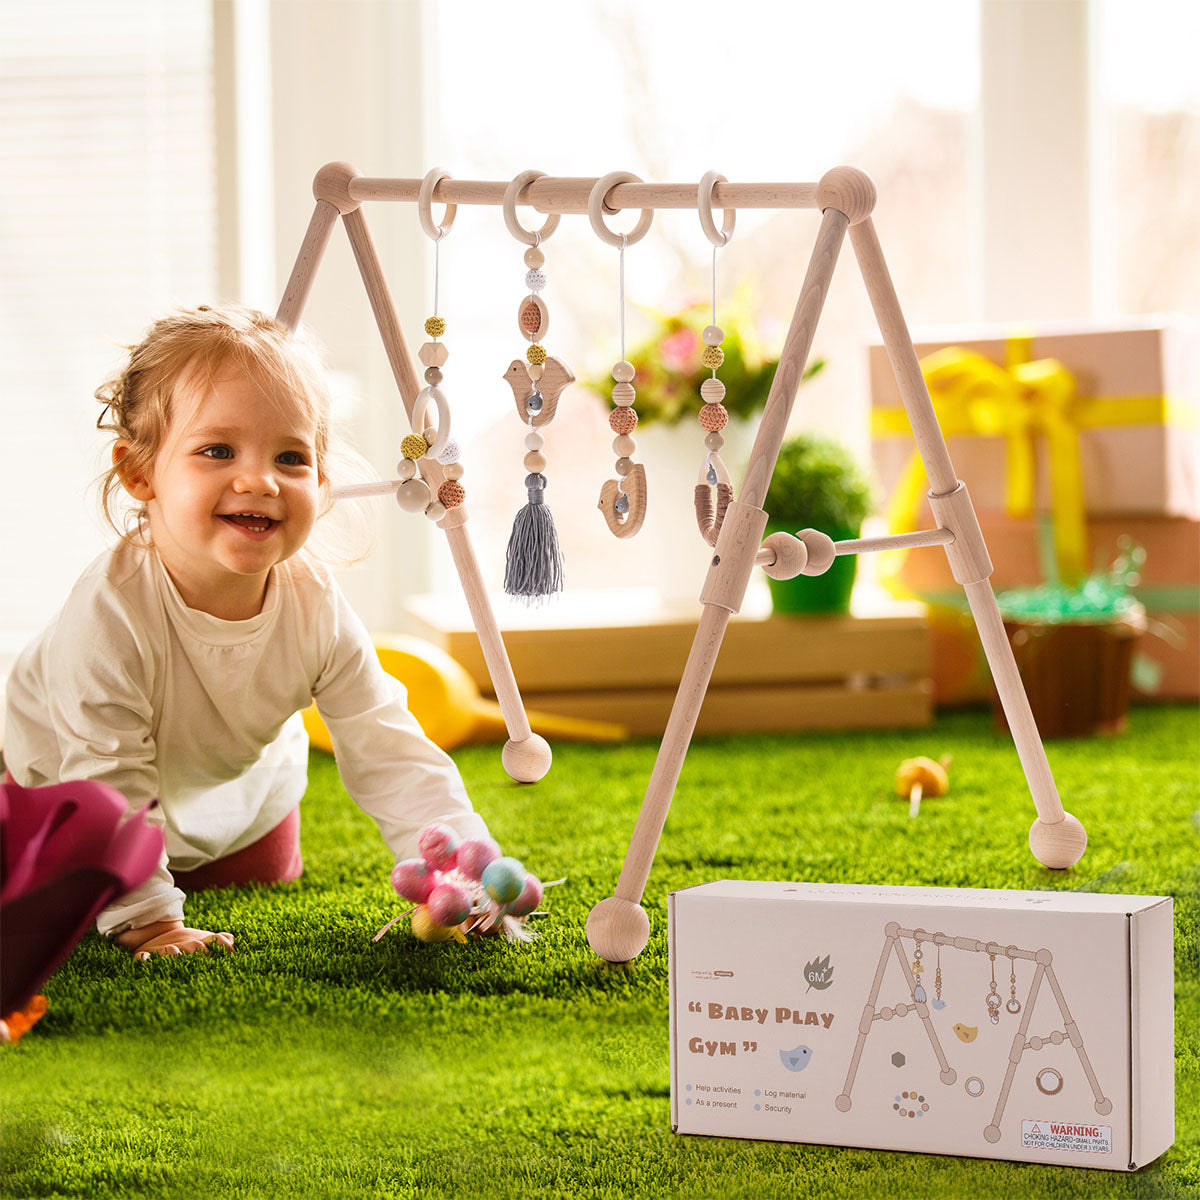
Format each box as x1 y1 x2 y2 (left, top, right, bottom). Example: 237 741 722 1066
408 596 932 736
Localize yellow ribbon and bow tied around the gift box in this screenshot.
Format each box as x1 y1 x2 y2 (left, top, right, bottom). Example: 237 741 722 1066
871 336 1172 583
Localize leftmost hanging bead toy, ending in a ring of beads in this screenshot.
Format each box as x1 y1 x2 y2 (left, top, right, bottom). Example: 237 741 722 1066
396 167 467 521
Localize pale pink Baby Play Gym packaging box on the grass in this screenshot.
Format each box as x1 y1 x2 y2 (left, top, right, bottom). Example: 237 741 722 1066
670 880 1175 1171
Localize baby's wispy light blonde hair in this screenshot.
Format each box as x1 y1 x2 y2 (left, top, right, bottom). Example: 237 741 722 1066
96 305 330 547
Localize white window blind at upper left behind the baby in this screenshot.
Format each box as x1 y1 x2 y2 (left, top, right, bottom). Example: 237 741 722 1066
0 0 216 658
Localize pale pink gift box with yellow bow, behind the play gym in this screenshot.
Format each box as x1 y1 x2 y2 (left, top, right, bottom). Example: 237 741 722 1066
868 318 1200 527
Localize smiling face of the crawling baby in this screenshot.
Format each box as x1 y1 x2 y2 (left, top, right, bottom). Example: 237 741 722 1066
148 373 320 619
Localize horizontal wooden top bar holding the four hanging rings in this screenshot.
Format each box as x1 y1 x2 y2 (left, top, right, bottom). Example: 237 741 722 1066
349 175 817 214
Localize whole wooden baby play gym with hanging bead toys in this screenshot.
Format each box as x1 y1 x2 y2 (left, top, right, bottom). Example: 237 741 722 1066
277 163 1087 962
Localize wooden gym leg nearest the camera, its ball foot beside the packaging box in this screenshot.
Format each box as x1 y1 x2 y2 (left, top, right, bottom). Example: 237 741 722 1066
587 209 848 962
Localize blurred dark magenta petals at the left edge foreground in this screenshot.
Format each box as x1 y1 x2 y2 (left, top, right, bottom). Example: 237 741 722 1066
0 774 162 1014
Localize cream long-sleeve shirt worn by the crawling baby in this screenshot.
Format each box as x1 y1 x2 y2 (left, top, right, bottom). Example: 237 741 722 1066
4 545 486 935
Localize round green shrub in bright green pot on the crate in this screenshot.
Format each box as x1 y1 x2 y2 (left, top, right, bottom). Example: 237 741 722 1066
763 434 872 613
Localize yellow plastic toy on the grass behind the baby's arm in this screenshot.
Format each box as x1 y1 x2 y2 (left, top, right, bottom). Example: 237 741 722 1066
304 634 629 754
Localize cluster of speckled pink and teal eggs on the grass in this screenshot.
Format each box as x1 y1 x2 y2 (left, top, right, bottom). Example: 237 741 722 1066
372 822 564 943
